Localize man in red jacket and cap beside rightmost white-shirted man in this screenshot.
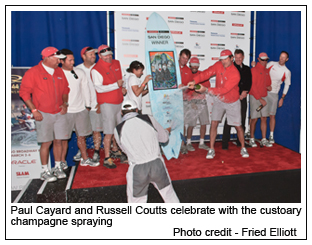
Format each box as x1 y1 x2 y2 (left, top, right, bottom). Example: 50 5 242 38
249 52 272 147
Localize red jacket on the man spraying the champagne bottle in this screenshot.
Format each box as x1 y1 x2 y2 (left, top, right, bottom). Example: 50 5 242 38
194 61 240 103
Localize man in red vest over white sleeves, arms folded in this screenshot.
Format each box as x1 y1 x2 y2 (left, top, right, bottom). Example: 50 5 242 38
91 44 126 168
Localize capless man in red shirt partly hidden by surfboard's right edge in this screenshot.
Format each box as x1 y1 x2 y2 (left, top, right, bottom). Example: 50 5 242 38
179 49 193 154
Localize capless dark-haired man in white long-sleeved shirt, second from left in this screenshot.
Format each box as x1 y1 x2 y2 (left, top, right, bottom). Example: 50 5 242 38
61 49 100 167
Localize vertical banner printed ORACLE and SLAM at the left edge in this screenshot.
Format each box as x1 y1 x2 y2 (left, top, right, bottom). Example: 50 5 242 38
11 68 41 190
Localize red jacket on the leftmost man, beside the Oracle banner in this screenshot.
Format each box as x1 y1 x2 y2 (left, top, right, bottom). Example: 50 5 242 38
19 61 69 114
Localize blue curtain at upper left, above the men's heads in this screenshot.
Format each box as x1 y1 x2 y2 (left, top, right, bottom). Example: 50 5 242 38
12 11 107 66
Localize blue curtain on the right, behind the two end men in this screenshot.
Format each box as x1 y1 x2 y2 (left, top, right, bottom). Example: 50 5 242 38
255 11 306 152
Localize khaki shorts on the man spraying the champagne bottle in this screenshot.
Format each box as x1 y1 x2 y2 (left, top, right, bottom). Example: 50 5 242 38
211 97 242 126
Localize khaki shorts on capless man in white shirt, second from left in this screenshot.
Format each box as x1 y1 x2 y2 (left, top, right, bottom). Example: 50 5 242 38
66 109 92 136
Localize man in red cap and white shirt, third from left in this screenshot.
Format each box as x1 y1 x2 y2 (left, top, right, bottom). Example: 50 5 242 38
74 46 103 162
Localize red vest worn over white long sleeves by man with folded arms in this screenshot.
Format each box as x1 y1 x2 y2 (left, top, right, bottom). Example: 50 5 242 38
92 59 123 105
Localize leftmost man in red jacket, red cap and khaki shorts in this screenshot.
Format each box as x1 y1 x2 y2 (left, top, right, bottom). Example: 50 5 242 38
19 47 69 182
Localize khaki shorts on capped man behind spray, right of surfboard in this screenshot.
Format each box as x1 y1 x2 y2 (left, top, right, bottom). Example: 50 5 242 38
183 99 209 127
